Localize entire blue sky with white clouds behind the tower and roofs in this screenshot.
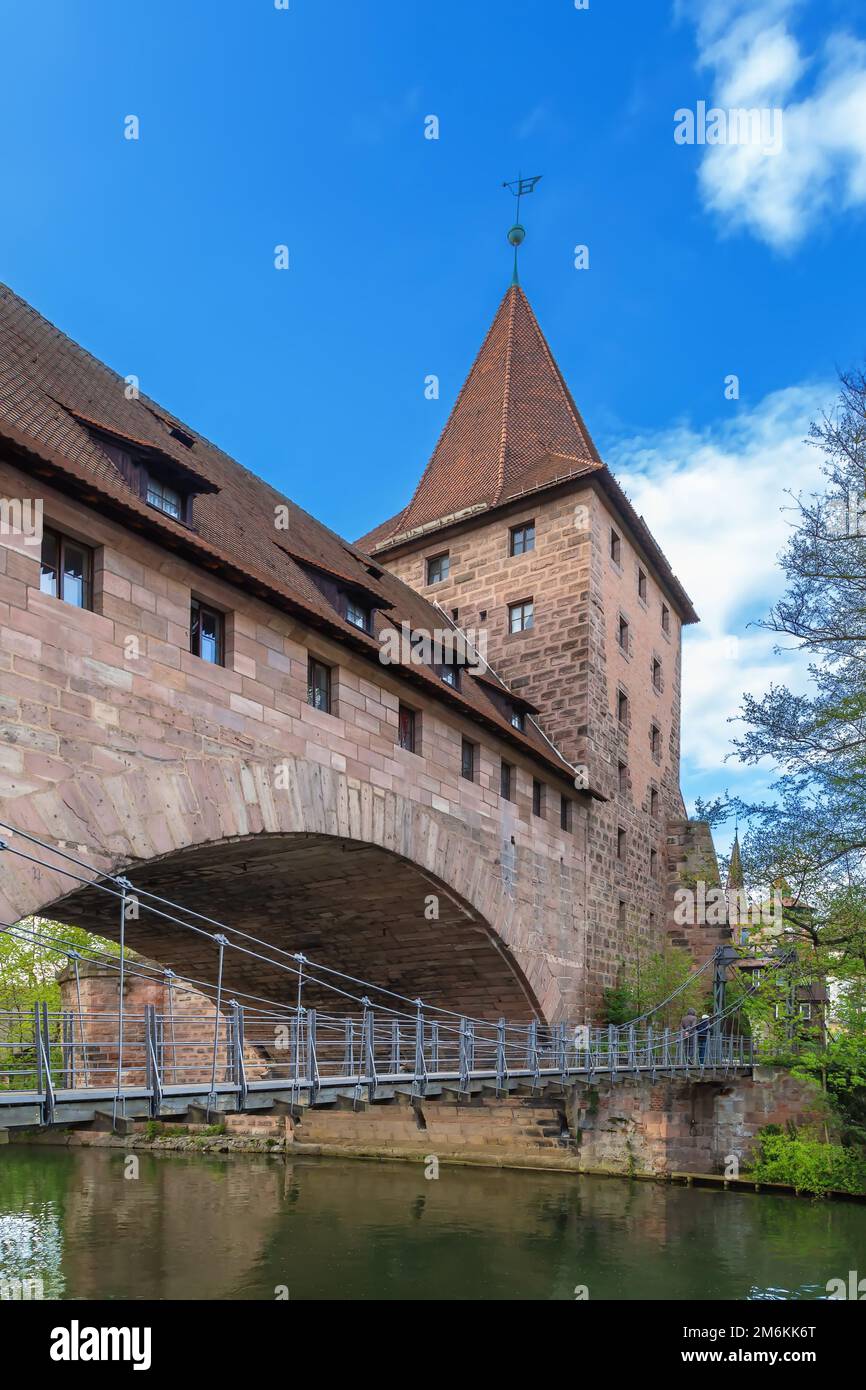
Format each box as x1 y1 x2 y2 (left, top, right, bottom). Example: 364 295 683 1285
0 0 866 839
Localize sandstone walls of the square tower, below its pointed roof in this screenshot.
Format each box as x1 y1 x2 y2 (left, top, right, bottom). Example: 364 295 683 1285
378 485 695 1015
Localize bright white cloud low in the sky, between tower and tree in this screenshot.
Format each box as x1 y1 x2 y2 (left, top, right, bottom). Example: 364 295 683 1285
610 385 837 772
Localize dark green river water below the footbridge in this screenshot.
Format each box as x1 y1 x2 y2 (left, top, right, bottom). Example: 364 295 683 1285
0 1145 866 1300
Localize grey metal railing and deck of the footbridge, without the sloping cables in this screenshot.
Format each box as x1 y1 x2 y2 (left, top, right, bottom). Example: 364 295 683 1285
0 1001 755 1123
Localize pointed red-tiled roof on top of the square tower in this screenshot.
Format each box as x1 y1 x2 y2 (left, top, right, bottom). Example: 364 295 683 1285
361 285 603 545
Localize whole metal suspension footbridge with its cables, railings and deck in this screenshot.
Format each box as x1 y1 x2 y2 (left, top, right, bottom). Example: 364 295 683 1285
0 827 758 1129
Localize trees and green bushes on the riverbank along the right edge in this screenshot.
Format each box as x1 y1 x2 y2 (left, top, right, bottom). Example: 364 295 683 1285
696 368 866 1191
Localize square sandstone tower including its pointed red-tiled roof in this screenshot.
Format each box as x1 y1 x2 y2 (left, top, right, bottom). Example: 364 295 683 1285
359 285 712 1002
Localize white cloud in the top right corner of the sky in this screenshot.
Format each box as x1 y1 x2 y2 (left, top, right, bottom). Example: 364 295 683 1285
678 0 866 250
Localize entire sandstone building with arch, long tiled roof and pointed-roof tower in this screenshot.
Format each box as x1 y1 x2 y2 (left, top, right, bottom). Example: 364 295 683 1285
0 279 717 1020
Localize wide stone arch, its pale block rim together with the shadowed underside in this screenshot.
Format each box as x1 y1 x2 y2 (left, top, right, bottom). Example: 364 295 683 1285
0 758 577 1020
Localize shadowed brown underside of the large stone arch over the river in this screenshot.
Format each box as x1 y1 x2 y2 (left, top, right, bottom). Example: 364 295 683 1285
39 833 541 1020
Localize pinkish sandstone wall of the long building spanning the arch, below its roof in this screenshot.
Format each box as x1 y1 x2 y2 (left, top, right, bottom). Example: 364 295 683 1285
0 461 592 1019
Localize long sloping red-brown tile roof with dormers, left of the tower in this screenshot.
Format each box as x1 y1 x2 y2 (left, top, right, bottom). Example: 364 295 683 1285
0 285 603 780
